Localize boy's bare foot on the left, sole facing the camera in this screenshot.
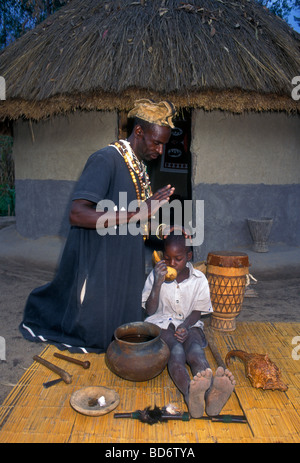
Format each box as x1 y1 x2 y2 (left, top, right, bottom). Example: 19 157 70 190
188 368 212 418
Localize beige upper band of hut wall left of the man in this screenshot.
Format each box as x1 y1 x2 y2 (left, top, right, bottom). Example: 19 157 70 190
13 111 118 180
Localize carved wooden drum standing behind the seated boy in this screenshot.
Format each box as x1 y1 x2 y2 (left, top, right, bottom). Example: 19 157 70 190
206 251 249 331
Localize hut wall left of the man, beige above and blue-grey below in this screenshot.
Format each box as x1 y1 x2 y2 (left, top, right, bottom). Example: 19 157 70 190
13 111 117 239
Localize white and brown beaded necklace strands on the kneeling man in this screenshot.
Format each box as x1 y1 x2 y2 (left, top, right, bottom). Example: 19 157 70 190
111 140 152 202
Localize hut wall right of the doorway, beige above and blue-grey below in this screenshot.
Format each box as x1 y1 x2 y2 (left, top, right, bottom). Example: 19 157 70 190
191 110 300 259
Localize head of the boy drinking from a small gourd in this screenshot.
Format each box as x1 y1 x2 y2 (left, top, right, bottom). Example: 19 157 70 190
164 233 193 274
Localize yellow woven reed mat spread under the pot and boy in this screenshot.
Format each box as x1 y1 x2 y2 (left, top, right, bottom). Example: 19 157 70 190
0 322 300 444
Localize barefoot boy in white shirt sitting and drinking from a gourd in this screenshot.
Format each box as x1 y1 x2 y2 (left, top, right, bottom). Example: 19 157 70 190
142 234 236 418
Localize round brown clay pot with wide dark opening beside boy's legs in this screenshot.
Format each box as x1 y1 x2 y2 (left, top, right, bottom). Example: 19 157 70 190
106 322 170 381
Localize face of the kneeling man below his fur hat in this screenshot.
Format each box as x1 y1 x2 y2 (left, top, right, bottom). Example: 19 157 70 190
136 124 171 161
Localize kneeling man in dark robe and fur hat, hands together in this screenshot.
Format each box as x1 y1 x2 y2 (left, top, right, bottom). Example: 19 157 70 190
20 100 175 353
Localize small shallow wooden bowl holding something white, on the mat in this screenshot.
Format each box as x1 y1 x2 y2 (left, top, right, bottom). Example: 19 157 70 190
70 386 120 416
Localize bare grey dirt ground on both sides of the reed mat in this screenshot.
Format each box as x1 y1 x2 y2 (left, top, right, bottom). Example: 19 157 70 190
0 254 300 404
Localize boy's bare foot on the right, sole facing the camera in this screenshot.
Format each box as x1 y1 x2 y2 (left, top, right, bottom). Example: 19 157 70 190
205 367 236 416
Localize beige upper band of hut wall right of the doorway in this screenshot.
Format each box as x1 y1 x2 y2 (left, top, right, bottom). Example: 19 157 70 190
191 110 300 186
